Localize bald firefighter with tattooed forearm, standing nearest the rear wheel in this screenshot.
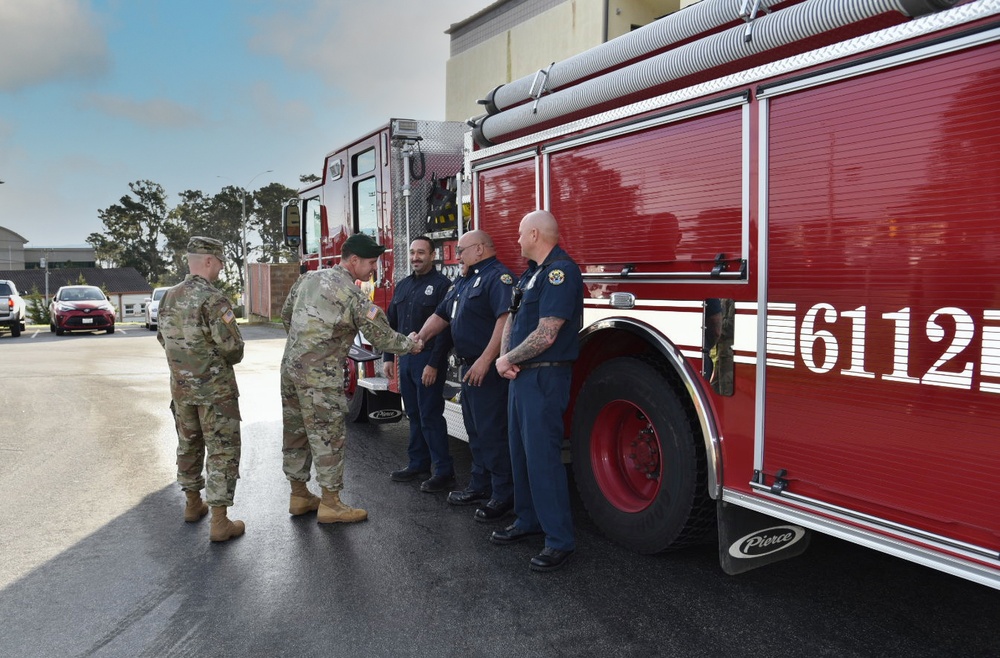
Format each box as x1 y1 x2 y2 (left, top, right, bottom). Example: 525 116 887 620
490 210 583 571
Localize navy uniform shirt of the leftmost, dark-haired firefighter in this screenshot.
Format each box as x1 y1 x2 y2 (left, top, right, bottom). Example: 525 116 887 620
383 268 451 370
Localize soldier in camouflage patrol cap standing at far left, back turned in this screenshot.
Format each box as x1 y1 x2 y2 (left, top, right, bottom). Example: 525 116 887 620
157 236 245 541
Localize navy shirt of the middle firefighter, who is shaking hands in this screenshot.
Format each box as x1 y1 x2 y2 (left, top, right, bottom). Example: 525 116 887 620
435 256 514 359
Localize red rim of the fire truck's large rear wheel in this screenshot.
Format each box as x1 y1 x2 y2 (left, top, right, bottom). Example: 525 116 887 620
590 400 662 512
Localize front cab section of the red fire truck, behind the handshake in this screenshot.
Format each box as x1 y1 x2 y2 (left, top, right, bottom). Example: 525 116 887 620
283 119 469 420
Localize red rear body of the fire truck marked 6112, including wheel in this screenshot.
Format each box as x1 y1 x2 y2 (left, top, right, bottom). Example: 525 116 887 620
286 0 1000 588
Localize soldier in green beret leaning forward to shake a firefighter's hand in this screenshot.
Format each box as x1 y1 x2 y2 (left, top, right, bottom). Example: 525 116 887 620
281 234 423 523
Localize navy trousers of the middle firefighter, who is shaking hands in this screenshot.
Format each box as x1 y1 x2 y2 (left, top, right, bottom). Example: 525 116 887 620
461 366 514 503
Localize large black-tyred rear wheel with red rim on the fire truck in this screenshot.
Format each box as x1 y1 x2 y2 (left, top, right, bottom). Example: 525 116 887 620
571 357 715 553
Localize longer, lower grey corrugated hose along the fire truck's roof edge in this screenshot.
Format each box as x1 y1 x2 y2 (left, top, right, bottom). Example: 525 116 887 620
473 0 957 146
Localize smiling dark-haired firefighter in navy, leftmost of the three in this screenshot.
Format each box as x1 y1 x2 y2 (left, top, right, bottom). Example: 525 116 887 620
384 236 455 486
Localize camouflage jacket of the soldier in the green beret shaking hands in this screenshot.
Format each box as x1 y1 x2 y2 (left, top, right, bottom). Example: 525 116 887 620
281 265 413 388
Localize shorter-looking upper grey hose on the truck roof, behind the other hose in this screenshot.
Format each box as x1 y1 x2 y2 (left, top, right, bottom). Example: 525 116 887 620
483 0 787 114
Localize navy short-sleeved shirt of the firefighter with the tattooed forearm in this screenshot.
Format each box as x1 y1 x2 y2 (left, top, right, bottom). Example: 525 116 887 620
508 245 583 363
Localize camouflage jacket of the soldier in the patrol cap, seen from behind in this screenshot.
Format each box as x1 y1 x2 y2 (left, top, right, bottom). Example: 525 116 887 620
156 274 243 405
